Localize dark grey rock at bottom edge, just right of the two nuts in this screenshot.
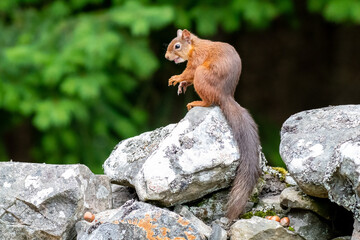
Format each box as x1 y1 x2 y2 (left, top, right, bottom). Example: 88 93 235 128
288 210 334 240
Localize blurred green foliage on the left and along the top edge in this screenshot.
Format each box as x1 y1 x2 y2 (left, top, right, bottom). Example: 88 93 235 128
0 0 360 172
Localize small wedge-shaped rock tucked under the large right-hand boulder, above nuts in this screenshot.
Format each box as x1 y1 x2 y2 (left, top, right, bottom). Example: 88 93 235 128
280 187 337 220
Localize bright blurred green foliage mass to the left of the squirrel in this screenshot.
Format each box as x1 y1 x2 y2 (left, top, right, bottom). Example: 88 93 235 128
0 0 174 172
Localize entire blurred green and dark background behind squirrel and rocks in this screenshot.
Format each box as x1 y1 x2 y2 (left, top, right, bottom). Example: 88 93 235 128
0 0 360 173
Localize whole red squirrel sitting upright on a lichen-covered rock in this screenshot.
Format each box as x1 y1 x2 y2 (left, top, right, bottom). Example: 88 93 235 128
165 29 260 220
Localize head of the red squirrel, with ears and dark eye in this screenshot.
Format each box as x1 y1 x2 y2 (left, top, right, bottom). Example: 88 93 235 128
165 29 195 63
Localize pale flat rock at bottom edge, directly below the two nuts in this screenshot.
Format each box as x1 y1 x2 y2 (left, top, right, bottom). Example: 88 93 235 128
230 217 304 240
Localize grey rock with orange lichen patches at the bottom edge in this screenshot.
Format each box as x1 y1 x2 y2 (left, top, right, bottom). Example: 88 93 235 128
76 201 205 240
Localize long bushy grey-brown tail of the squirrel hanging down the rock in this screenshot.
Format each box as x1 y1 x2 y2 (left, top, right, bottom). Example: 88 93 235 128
220 96 260 220
